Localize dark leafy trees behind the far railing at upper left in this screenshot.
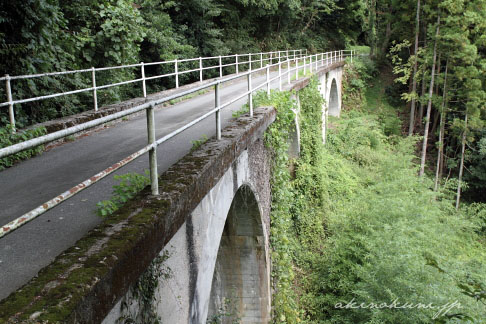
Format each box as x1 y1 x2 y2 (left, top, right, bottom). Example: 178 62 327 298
0 0 367 127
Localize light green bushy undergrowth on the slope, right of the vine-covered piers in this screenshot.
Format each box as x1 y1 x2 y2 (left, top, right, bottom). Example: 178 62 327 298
309 113 486 323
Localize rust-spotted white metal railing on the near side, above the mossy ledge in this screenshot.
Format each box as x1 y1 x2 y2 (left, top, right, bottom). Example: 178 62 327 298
0 50 354 238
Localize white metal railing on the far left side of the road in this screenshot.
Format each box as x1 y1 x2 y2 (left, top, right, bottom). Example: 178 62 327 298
0 49 307 132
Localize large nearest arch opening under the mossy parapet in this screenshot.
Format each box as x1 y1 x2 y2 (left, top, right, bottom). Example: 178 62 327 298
207 185 270 324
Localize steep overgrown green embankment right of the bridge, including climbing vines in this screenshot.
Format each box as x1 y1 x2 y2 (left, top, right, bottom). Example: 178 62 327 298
267 59 486 323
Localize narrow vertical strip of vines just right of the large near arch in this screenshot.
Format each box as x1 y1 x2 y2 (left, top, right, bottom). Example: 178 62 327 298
254 91 300 323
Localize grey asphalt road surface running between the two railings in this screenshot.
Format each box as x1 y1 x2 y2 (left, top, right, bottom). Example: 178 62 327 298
0 72 286 300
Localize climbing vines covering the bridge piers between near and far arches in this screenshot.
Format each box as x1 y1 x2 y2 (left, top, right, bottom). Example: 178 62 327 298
255 78 326 323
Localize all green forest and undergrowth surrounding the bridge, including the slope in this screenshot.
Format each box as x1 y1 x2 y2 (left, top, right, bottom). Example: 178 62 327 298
0 0 486 323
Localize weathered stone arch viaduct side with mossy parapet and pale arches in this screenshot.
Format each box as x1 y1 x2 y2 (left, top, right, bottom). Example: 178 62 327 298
0 62 344 324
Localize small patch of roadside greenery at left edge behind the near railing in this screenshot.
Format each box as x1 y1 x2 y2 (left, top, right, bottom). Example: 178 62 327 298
0 125 46 170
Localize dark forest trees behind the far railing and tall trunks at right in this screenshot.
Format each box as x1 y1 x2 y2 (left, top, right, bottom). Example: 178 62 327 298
0 0 486 204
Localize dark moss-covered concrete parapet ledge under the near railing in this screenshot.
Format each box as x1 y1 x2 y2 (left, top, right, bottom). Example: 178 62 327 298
0 107 276 323
